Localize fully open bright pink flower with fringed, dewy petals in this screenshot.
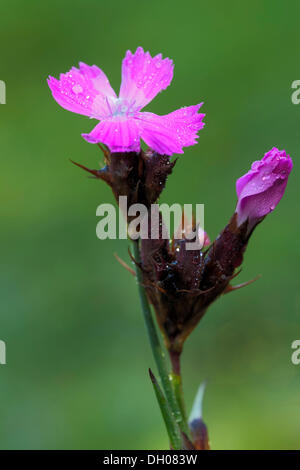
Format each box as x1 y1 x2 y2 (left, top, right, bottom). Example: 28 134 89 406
48 47 205 155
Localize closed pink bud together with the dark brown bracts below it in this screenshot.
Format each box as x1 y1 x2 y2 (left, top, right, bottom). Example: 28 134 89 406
141 148 292 356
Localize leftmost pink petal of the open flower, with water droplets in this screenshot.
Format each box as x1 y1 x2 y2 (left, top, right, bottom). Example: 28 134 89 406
48 62 116 119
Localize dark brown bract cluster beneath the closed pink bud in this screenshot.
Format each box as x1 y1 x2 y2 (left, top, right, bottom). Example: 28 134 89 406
140 215 253 356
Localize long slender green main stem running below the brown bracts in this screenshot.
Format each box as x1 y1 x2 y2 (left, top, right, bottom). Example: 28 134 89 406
133 241 184 449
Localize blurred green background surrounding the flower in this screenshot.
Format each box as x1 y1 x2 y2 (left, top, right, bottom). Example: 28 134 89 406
0 0 300 449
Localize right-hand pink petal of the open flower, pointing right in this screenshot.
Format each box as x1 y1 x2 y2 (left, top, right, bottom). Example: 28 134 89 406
136 103 205 155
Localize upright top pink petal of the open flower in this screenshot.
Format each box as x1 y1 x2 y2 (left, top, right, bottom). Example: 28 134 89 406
119 47 174 110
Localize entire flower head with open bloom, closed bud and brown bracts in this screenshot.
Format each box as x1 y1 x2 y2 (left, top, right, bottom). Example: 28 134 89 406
48 47 293 449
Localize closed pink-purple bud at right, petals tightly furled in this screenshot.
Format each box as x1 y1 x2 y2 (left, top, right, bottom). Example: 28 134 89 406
236 147 293 229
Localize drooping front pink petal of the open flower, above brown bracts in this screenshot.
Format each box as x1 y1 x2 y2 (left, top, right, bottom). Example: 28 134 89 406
82 117 140 153
